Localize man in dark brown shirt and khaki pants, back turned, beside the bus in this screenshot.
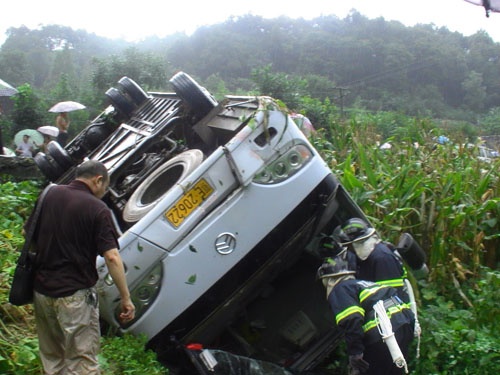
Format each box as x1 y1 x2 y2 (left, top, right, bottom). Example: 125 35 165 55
28 160 135 375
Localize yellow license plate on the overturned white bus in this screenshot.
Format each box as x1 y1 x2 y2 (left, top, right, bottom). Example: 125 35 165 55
165 178 214 228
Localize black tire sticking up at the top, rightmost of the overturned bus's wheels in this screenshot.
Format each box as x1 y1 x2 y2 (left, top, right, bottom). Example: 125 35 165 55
170 72 218 118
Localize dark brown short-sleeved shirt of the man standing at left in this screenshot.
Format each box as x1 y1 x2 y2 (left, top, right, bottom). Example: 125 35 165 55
28 180 118 297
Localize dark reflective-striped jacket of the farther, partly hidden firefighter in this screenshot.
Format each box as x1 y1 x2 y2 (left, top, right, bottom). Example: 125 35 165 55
356 242 410 303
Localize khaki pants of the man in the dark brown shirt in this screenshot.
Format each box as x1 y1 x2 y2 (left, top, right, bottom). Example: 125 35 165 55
34 288 100 375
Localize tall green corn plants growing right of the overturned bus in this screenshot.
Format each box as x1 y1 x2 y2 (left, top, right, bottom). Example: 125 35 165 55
315 119 500 292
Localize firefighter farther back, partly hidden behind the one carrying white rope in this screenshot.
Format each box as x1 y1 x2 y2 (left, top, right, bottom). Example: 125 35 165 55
336 218 410 303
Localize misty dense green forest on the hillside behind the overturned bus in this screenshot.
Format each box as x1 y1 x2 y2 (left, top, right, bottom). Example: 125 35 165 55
0 11 500 143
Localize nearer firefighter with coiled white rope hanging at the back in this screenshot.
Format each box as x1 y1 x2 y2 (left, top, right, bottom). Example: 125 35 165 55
317 251 415 375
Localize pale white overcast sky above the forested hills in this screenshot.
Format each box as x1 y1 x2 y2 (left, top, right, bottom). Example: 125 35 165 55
0 0 500 44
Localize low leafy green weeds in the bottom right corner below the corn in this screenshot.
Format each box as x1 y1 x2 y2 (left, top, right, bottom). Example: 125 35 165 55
412 269 500 375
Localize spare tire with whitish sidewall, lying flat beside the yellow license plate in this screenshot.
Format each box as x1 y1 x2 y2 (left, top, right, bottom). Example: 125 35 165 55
123 150 203 223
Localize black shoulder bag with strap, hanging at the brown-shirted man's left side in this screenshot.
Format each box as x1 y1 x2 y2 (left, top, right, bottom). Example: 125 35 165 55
9 184 52 306
